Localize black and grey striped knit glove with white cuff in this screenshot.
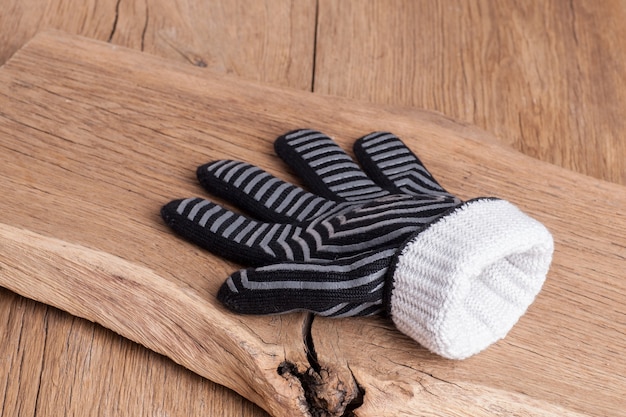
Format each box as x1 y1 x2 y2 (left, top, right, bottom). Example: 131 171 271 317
161 130 553 359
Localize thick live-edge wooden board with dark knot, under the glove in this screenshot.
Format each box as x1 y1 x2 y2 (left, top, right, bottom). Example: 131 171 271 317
0 32 626 416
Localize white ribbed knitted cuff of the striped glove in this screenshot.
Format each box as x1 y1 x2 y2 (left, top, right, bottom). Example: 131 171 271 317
389 199 554 359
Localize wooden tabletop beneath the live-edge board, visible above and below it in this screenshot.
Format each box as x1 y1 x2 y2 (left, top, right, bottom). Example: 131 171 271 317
0 0 626 416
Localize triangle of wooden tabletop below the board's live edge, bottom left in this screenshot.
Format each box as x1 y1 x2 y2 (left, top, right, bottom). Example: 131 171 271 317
0 289 264 416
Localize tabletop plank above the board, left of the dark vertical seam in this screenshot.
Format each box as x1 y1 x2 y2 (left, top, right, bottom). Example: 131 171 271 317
0 0 316 90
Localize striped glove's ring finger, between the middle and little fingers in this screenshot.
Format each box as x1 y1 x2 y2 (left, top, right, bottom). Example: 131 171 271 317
274 129 389 201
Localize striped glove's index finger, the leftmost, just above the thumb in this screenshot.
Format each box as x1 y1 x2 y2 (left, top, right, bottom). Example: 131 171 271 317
161 198 307 266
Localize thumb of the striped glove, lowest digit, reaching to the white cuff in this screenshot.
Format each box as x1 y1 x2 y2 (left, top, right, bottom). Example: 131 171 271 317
217 249 395 317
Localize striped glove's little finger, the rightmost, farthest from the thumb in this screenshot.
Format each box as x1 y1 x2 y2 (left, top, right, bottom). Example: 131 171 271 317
354 132 455 198
